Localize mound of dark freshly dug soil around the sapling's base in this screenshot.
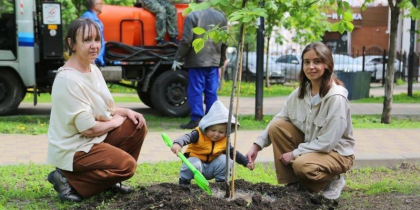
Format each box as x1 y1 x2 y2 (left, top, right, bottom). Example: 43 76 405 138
74 180 338 210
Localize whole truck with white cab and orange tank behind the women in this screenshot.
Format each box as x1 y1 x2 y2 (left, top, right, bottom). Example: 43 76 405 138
0 0 189 117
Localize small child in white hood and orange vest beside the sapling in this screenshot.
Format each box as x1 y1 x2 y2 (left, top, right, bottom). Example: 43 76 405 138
171 101 251 185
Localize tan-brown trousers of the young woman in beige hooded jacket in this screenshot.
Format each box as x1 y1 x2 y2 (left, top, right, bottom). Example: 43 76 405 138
268 120 354 192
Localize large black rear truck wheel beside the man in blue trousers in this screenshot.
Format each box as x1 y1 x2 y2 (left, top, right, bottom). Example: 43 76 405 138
151 70 190 117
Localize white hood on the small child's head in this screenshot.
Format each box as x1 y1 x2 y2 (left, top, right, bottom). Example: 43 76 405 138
198 101 239 133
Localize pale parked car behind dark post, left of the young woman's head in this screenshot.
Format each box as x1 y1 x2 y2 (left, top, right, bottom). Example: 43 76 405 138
225 51 286 84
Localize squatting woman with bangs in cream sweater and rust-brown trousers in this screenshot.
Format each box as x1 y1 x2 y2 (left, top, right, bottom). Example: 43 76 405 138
47 19 147 202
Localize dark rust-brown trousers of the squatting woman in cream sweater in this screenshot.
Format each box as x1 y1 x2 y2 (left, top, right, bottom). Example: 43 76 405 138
63 119 147 198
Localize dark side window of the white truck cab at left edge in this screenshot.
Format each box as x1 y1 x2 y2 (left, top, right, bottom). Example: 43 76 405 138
0 0 16 60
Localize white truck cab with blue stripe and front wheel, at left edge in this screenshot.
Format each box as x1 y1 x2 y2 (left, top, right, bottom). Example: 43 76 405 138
0 0 64 115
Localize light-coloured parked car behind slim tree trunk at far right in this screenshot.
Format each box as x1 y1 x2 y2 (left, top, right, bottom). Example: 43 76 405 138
355 55 403 81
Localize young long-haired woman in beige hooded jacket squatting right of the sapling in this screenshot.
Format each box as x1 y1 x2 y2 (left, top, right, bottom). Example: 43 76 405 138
247 42 355 199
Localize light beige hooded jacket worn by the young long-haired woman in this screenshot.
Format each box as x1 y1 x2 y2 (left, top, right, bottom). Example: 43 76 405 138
255 84 355 157
